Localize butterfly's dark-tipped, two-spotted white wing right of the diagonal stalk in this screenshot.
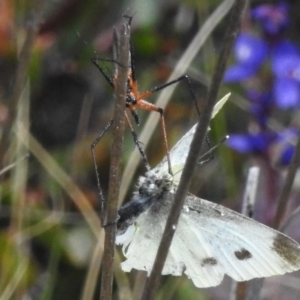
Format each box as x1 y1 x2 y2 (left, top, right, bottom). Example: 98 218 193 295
179 195 300 287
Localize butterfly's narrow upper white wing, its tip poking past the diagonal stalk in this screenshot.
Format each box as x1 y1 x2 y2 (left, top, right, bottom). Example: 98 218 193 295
151 93 230 183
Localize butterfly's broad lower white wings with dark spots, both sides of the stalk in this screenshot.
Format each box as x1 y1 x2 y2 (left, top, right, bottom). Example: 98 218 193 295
122 194 300 287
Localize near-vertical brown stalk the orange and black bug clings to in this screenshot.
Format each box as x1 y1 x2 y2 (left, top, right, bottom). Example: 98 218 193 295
100 23 130 300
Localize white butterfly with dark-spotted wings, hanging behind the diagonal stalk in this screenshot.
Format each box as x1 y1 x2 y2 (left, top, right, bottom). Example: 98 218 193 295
116 95 300 288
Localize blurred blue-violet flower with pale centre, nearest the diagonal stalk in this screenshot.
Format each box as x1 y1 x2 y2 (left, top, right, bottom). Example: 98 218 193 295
224 34 268 82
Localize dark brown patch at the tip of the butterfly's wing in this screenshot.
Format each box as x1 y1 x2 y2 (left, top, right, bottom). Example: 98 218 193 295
272 234 300 266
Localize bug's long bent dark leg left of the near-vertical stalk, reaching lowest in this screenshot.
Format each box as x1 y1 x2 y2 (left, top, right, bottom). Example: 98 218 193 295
91 120 114 227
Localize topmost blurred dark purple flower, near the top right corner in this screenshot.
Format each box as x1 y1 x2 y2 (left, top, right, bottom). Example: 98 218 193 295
252 2 290 35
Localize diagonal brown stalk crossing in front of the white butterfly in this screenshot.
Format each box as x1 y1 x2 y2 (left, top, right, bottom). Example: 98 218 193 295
142 0 247 300
